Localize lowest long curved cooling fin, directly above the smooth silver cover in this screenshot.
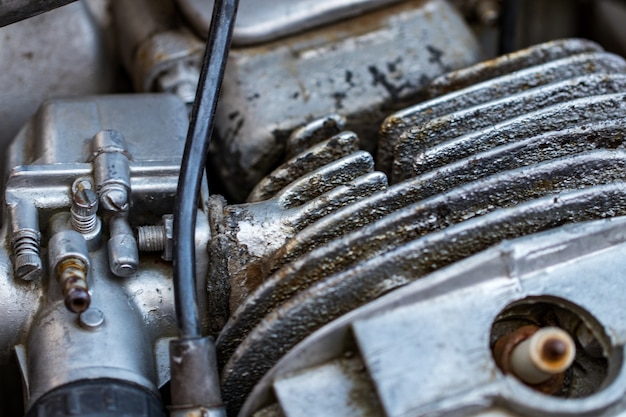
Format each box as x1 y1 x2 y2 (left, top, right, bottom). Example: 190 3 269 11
218 182 626 410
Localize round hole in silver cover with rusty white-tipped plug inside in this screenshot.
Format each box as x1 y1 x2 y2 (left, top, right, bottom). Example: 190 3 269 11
490 297 611 398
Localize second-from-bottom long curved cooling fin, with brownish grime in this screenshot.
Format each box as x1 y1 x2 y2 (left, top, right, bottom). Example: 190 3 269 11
218 151 626 366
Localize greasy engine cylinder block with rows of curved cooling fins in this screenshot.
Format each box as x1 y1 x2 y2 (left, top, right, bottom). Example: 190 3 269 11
211 39 626 416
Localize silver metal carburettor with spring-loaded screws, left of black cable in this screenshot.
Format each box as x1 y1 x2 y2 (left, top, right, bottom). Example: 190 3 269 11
0 95 208 416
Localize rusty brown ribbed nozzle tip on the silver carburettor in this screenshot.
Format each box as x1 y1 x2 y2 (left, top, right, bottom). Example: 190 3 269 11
57 258 91 313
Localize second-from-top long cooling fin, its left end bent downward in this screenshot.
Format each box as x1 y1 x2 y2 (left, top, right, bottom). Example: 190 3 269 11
376 52 626 172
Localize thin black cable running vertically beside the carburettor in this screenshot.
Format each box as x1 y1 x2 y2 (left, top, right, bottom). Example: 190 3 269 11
174 0 239 338
